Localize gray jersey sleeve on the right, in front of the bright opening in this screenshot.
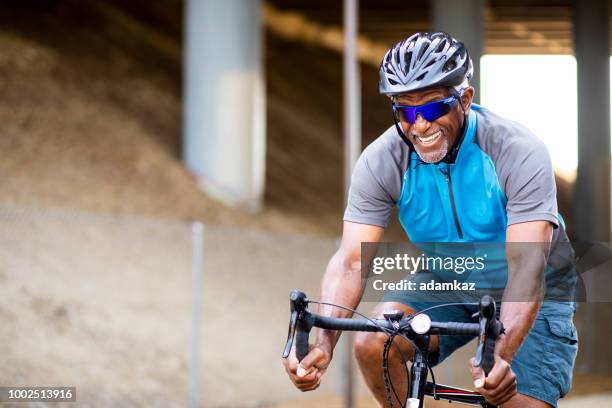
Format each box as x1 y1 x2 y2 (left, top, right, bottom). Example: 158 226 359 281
502 137 559 227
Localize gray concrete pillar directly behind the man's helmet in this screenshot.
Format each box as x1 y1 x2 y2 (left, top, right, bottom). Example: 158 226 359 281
432 0 485 103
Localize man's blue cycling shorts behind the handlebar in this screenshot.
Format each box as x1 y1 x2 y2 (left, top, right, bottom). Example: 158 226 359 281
383 292 578 407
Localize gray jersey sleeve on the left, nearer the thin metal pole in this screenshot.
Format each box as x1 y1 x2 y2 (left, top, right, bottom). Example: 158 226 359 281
344 149 395 228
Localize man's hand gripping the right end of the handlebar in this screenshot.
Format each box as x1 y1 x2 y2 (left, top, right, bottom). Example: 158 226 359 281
470 356 516 405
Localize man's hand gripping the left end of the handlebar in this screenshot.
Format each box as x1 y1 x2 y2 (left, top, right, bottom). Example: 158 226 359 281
283 344 332 391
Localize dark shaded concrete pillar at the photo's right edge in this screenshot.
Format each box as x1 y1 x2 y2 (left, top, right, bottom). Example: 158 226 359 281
572 0 612 373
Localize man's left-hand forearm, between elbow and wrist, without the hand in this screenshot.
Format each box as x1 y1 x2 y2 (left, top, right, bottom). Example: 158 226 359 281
317 252 364 350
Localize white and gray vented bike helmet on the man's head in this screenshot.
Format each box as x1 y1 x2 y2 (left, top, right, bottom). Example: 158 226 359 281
379 32 473 96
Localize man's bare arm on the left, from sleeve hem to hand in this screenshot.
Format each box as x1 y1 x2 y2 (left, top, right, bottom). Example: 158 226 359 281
283 222 384 391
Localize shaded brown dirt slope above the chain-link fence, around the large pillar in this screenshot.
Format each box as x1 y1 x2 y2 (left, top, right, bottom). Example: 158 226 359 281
0 1 352 235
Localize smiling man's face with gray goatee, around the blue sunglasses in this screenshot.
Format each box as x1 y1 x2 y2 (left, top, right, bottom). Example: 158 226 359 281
397 87 474 163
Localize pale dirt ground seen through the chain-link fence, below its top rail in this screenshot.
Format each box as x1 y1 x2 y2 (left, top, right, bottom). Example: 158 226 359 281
0 207 334 407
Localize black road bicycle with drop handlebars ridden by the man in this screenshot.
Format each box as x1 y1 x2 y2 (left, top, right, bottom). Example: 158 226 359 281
283 290 504 408
